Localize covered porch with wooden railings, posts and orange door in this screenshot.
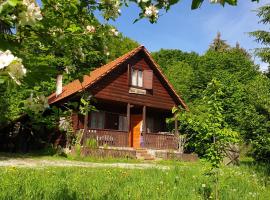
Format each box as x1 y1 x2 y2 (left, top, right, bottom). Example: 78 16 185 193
78 100 179 150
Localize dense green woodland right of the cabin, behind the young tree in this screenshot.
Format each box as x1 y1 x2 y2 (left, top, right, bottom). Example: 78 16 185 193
153 32 270 161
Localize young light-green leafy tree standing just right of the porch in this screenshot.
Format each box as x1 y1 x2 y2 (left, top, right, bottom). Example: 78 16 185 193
176 80 238 168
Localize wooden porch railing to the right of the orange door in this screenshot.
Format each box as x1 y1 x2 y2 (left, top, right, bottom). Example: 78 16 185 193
144 133 179 150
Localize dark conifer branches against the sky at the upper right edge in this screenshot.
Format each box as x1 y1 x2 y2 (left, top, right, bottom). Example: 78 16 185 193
250 4 270 74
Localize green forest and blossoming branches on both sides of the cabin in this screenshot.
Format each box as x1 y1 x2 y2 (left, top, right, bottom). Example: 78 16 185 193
0 0 270 162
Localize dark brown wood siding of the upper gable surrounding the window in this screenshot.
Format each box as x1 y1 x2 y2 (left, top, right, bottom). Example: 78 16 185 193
89 54 176 110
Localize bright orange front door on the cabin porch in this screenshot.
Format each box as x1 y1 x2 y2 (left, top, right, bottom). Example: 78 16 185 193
130 115 142 148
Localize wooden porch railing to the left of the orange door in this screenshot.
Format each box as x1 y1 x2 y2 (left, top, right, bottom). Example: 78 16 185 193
86 129 129 147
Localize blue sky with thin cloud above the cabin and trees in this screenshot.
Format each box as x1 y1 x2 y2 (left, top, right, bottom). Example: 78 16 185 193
102 0 270 70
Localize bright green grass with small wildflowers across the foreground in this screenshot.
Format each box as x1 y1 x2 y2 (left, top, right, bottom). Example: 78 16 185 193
0 162 270 200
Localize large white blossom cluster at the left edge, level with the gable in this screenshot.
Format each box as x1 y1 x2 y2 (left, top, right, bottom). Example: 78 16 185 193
0 50 27 85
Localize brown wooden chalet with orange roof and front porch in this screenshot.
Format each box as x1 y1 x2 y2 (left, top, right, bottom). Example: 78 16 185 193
49 46 187 149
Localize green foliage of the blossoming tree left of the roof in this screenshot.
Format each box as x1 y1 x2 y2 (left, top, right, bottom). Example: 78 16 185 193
0 0 137 138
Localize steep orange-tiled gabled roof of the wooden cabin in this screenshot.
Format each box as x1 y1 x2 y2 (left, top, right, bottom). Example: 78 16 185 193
48 46 188 109
